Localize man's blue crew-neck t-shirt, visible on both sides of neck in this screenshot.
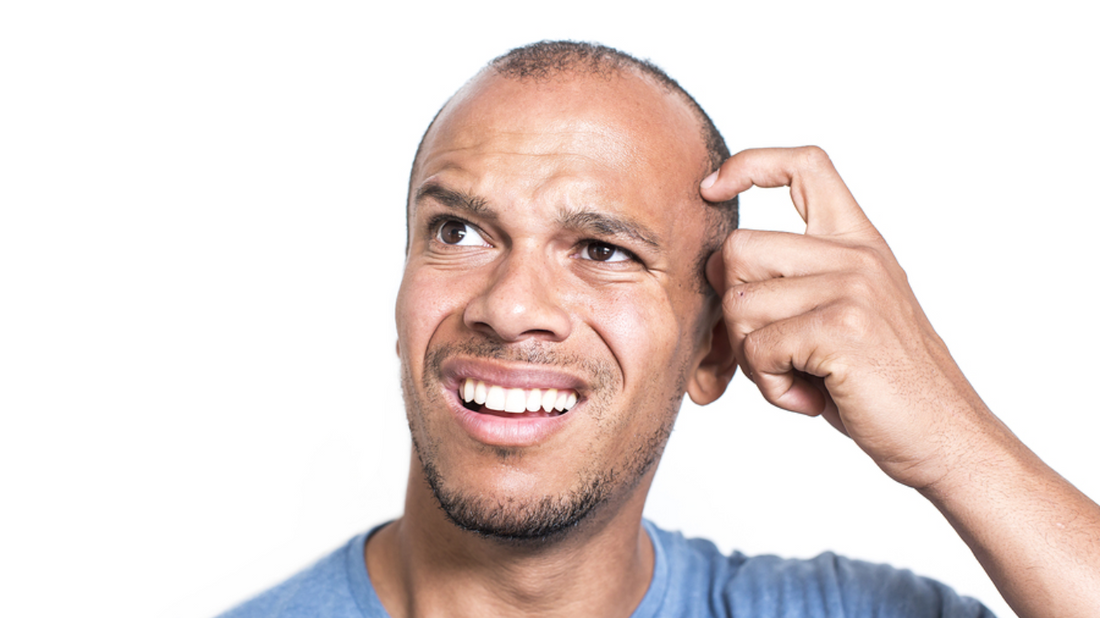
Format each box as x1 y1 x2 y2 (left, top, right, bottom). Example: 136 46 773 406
221 521 993 618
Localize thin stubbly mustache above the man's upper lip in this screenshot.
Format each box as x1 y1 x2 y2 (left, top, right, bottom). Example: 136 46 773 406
424 339 618 390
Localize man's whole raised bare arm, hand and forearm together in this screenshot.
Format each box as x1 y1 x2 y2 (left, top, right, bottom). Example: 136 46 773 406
701 147 1100 618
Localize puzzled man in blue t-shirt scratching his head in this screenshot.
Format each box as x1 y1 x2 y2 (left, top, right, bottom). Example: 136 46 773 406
221 43 1100 617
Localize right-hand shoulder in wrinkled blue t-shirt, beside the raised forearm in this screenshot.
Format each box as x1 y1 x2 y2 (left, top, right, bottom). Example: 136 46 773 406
648 525 992 618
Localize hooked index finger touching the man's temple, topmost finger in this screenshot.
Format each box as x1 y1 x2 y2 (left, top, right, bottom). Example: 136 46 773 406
700 146 873 235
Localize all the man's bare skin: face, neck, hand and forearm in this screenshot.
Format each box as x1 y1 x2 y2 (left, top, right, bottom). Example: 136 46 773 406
365 67 1100 617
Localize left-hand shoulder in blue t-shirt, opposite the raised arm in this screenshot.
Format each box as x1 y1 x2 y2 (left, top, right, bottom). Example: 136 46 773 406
219 534 371 618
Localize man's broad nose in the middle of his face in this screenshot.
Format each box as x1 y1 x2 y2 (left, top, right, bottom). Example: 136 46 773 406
463 250 572 342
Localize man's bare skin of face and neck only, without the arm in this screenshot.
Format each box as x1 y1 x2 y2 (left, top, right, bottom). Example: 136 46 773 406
376 69 721 616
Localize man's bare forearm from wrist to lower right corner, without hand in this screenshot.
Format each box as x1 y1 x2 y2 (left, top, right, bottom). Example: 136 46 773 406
922 410 1100 618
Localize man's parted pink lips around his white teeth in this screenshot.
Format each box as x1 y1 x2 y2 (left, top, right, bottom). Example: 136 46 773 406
442 358 586 446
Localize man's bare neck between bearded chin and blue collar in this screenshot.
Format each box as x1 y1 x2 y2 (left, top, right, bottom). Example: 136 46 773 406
365 453 655 618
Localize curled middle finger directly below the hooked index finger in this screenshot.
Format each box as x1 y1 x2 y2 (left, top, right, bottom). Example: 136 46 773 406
705 230 893 294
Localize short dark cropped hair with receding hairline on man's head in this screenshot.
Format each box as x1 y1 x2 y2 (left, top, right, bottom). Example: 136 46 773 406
405 41 738 256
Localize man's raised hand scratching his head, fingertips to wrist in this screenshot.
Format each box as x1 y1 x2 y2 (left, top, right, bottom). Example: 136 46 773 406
701 147 996 488
